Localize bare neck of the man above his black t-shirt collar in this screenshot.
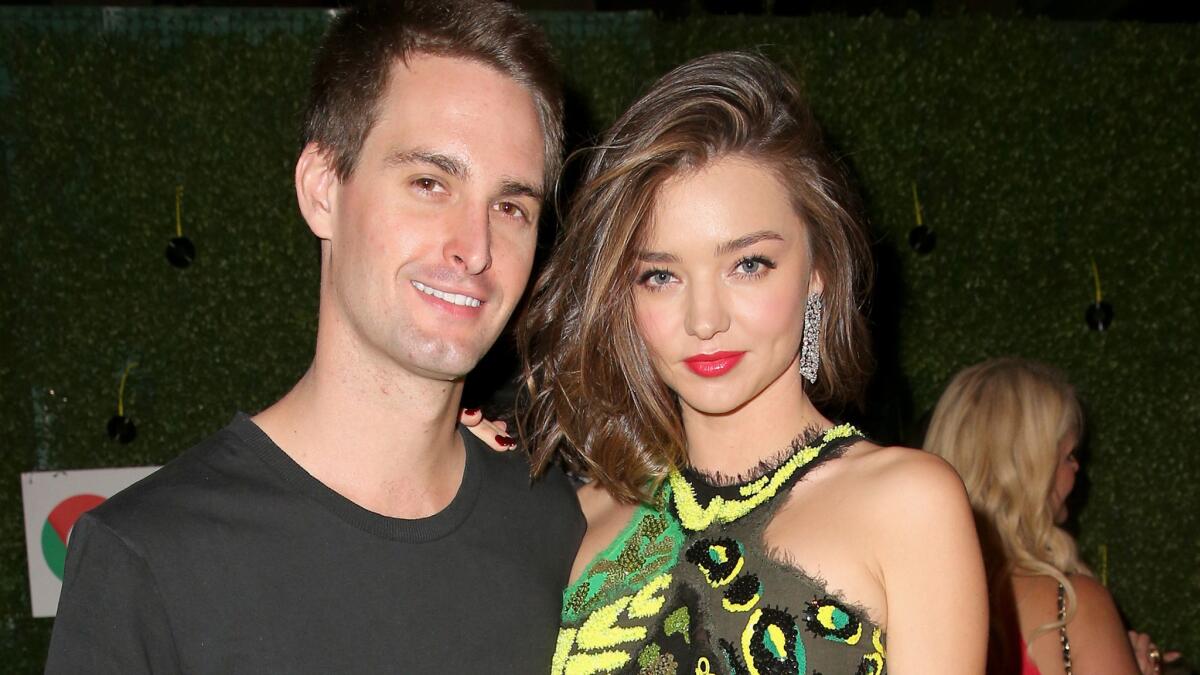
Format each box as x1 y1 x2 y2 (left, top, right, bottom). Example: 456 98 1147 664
253 350 466 519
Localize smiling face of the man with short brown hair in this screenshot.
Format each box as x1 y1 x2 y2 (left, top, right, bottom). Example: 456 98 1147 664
310 54 544 381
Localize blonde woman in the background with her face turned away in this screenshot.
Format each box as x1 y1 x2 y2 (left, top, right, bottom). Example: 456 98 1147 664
925 358 1158 675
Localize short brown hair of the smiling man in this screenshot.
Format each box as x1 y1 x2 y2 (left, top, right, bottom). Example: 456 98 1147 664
304 0 563 193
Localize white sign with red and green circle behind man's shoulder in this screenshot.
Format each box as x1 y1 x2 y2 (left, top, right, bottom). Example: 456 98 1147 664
20 466 158 616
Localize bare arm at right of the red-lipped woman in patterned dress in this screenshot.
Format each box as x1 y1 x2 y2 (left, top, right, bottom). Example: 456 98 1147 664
877 448 988 675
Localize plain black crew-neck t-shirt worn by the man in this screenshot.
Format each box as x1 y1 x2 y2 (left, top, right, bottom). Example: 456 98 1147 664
47 414 584 674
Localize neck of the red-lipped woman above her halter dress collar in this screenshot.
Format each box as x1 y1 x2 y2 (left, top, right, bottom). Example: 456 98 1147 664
682 365 830 476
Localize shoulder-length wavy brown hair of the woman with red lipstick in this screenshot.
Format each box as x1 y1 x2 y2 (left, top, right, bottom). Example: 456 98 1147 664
517 52 870 502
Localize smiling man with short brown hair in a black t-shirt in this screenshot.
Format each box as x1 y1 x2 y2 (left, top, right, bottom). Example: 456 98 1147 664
47 0 583 673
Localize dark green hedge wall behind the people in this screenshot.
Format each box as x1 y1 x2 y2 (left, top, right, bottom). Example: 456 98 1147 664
0 8 1200 671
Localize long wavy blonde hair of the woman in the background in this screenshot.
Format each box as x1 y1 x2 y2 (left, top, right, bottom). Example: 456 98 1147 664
925 357 1092 643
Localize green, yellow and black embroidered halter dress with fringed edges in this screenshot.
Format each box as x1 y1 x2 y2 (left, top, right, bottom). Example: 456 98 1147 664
553 425 884 675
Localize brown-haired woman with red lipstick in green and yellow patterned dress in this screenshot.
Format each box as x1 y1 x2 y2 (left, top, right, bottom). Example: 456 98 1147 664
517 53 986 675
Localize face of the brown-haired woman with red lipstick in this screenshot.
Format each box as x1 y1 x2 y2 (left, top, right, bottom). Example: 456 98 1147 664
634 156 822 414
